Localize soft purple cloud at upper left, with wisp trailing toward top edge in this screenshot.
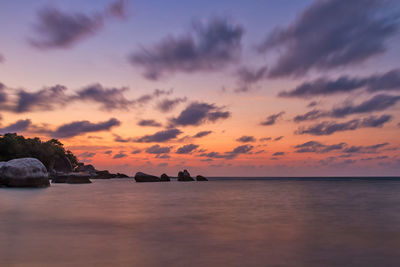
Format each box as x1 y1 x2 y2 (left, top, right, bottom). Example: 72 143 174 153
29 1 124 49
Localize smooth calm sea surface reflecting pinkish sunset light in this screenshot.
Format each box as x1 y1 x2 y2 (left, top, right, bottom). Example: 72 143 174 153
0 179 400 267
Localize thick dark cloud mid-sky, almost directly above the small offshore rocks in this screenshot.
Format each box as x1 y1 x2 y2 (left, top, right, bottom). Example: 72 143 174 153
170 102 231 126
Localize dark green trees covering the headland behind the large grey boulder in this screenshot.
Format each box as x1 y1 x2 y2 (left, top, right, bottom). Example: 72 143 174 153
0 133 78 169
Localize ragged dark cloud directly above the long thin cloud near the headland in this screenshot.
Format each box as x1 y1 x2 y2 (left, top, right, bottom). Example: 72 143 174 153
70 84 134 110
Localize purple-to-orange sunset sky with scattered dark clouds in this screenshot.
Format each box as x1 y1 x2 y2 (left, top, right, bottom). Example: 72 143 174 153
0 0 400 176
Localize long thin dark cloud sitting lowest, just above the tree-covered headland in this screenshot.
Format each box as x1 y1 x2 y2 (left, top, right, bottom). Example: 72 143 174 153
50 118 121 138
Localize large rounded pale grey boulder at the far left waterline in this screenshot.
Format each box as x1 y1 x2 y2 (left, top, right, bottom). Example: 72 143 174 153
0 158 50 187
